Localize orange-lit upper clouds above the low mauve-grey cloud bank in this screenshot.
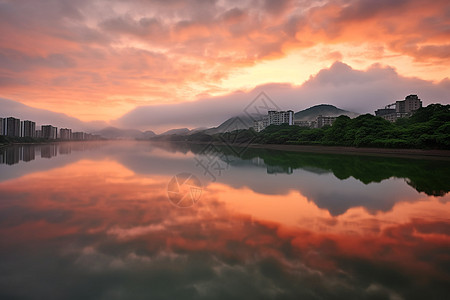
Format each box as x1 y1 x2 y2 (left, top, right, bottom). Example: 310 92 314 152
0 0 450 120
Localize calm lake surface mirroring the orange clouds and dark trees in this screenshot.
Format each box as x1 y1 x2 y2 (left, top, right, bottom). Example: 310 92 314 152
0 142 450 300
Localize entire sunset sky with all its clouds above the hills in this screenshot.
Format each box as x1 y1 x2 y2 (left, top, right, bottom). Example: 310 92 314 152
0 0 450 131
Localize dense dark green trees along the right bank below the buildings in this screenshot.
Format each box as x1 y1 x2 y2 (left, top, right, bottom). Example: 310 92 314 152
187 104 450 149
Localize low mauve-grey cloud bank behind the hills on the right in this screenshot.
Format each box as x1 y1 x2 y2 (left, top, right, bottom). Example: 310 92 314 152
114 62 450 132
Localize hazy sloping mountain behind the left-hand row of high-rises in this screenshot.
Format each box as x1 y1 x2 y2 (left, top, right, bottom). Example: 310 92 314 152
0 98 107 132
